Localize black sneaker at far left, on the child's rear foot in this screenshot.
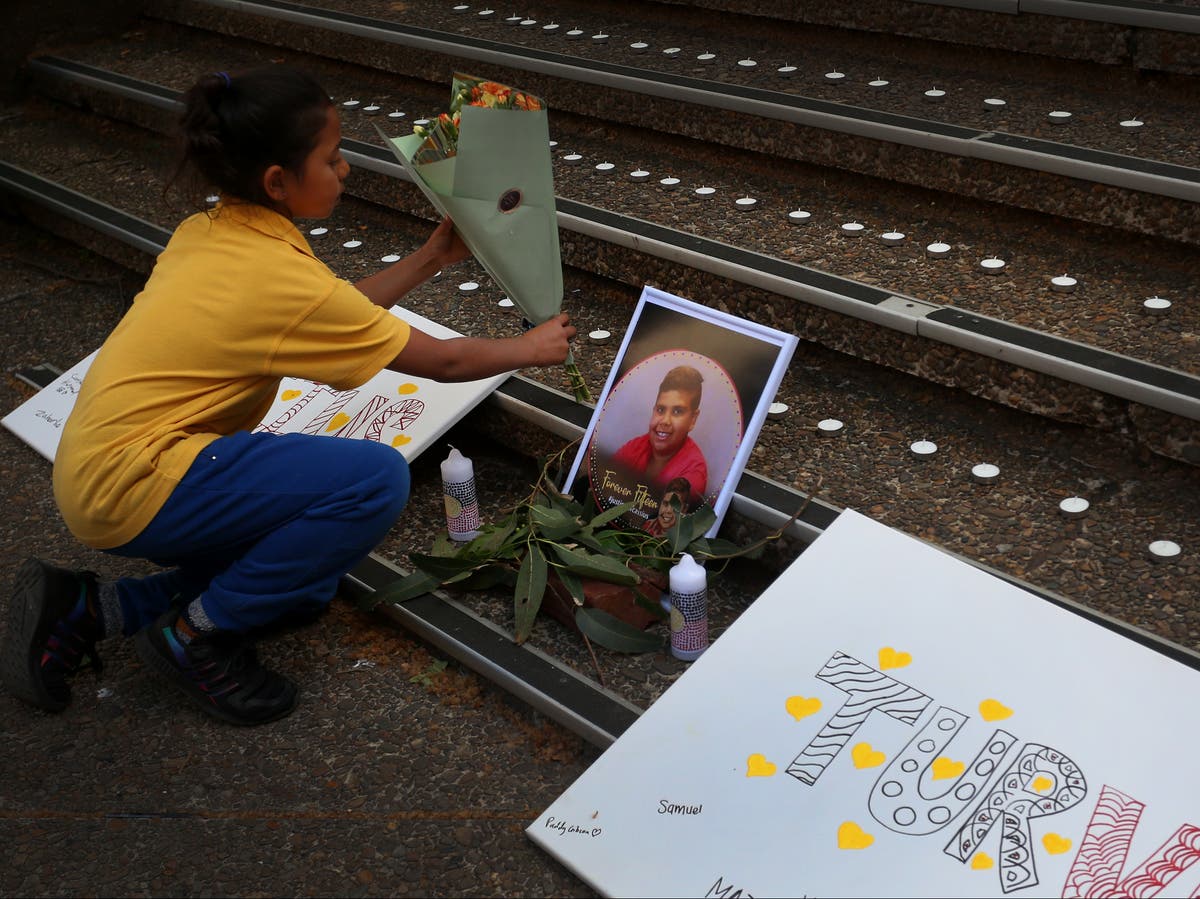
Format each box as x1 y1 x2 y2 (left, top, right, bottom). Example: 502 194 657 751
0 559 104 712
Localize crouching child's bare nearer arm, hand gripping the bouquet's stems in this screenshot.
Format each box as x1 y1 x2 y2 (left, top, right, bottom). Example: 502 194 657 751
388 312 575 380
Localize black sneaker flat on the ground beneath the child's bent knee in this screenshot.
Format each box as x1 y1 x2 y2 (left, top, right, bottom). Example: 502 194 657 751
134 610 296 724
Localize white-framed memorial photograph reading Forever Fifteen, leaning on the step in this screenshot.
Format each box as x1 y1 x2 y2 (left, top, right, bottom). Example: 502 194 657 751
563 287 799 535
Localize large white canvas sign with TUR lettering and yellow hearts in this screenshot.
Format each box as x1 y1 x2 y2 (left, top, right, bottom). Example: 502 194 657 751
527 511 1200 899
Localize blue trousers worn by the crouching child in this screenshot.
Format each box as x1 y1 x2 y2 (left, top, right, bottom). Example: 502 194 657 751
100 432 409 636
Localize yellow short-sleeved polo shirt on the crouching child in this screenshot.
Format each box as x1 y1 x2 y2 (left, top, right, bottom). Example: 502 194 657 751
54 204 409 549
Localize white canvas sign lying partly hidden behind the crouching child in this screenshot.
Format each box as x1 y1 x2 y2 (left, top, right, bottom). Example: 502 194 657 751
2 306 509 461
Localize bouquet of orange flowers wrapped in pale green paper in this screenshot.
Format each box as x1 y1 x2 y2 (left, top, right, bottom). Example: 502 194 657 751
379 73 592 402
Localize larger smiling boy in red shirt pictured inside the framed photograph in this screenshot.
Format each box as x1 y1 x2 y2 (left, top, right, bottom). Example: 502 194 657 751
612 365 708 510
